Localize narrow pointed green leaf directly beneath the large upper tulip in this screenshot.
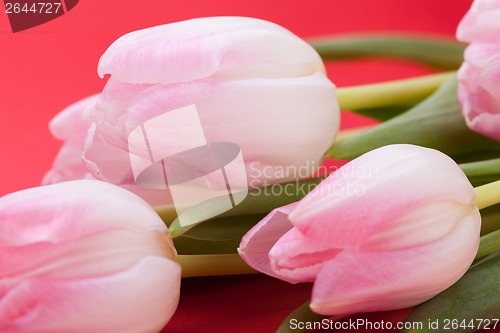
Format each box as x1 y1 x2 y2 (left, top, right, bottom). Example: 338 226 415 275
169 178 323 238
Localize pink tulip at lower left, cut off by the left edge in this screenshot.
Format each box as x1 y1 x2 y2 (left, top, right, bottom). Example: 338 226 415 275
0 180 180 333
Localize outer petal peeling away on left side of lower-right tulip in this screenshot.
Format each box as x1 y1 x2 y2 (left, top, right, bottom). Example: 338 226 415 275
238 203 296 278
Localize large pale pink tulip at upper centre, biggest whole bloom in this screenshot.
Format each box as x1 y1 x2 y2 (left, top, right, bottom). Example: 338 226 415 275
85 17 339 186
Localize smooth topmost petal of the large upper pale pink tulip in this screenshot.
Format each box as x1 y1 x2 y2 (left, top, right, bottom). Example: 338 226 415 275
98 17 324 83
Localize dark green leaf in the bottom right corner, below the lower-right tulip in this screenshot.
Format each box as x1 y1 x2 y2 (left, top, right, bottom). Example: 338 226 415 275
402 254 500 333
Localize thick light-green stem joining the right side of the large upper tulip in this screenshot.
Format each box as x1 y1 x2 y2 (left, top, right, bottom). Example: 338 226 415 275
337 71 456 110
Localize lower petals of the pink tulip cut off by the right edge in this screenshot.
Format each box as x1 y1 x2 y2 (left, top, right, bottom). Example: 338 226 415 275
458 30 500 141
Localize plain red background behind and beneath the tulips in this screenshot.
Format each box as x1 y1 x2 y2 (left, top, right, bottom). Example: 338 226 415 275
0 0 488 332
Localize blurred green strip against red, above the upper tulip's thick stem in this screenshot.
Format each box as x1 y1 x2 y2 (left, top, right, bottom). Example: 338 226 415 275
310 35 466 70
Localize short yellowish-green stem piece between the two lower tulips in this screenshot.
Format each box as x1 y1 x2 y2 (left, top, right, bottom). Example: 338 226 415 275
177 254 258 277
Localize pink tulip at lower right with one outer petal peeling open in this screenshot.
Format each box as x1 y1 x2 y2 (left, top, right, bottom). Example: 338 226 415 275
239 145 481 315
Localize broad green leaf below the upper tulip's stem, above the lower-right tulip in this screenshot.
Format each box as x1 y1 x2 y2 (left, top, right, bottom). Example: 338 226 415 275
327 78 500 163
